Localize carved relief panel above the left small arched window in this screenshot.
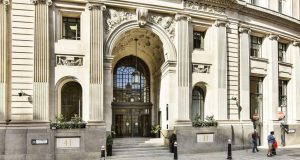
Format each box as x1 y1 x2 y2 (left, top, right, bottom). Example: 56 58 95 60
56 55 83 66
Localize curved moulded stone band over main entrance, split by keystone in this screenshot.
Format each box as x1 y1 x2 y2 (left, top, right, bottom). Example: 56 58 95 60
105 20 177 61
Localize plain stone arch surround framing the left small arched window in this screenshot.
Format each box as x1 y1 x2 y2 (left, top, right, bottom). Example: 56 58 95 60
55 76 84 119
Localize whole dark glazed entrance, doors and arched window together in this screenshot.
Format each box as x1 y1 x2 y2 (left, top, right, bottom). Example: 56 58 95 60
112 55 152 137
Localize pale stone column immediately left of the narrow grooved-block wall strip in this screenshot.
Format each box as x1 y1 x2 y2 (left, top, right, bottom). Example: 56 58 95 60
214 20 229 120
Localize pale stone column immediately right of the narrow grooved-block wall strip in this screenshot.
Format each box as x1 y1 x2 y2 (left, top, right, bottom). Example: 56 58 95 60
239 27 250 120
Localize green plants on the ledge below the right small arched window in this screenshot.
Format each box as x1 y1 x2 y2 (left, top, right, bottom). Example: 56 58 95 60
192 115 218 127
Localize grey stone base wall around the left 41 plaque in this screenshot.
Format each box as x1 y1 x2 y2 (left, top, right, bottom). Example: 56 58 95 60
0 127 106 160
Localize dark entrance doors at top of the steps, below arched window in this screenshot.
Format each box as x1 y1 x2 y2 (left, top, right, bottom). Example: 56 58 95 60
113 108 150 137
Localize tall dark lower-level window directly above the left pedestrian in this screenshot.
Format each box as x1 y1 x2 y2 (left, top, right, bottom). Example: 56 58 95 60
250 77 263 119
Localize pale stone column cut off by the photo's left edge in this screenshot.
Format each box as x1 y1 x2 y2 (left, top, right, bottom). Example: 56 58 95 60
0 0 9 121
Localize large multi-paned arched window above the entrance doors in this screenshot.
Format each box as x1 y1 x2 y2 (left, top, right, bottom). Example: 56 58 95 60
114 56 150 103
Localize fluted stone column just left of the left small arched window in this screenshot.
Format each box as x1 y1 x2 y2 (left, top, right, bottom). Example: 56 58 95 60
32 0 52 121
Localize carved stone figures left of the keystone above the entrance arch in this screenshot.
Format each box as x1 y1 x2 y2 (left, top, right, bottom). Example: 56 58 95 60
105 9 135 33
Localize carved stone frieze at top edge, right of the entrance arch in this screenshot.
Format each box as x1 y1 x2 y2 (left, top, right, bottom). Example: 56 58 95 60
184 0 225 15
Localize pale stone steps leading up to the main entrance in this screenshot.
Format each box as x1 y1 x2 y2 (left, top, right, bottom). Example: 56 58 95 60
107 138 173 160
